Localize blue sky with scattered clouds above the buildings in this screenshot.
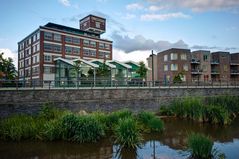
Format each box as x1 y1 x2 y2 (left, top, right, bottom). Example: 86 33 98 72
0 0 239 67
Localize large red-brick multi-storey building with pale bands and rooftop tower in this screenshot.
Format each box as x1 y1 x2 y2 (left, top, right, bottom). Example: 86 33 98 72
18 15 112 82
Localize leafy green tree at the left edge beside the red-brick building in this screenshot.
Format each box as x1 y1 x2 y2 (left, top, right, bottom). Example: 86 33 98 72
0 53 17 80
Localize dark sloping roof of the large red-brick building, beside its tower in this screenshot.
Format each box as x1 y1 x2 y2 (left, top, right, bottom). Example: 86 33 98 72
44 23 100 36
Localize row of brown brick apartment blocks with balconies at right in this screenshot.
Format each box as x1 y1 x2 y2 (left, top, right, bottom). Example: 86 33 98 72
147 48 239 82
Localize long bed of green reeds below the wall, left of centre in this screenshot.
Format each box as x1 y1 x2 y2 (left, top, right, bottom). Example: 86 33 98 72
0 104 163 148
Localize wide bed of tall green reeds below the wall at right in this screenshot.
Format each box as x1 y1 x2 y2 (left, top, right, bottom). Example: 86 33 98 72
159 96 239 125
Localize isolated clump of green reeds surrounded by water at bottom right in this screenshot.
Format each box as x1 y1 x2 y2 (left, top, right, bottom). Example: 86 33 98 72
188 133 213 159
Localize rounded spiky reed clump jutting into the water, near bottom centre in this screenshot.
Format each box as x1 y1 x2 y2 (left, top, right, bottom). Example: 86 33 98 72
114 117 142 148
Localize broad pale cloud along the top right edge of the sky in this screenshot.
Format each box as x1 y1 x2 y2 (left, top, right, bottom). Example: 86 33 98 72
146 0 239 12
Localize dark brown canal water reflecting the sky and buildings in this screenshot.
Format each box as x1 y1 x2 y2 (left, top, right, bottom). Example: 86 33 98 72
0 118 239 159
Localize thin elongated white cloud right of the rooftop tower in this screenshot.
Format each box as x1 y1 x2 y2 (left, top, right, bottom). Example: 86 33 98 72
141 12 191 21
